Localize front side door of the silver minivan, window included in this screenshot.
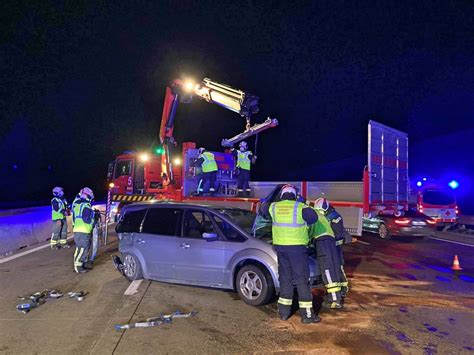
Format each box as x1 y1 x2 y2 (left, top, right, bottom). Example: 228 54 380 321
175 209 225 287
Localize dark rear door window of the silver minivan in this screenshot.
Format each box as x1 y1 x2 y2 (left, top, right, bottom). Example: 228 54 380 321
142 208 183 236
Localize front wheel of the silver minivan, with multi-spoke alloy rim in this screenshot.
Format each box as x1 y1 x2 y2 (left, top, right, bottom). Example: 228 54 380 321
235 265 275 306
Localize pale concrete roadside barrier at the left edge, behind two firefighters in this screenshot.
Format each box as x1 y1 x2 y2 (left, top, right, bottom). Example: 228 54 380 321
0 205 104 257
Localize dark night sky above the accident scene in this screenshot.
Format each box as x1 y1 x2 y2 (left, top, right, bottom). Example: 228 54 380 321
0 0 474 209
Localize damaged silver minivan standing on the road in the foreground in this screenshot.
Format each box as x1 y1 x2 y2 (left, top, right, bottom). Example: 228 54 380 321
114 202 320 306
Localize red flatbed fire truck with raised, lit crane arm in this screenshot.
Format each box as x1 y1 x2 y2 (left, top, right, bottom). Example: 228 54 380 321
108 79 409 239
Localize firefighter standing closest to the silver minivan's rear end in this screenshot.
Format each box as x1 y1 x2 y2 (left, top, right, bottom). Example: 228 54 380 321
73 187 94 274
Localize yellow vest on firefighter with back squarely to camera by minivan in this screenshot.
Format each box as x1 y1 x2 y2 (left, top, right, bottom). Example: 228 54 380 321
269 200 309 245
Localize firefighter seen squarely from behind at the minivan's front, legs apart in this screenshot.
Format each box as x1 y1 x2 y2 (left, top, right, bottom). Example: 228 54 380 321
262 185 321 324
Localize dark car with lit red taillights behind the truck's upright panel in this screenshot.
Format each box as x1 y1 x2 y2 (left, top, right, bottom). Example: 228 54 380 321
362 208 436 239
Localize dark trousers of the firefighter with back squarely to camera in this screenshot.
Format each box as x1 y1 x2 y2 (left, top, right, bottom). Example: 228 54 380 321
276 246 313 308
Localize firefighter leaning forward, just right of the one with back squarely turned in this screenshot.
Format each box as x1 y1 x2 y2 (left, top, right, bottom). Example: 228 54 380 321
309 200 343 309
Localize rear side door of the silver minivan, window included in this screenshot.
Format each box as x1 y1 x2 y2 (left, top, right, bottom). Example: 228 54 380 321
135 206 183 280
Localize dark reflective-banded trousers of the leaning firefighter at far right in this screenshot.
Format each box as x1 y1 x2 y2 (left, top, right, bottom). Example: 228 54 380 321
314 236 342 302
